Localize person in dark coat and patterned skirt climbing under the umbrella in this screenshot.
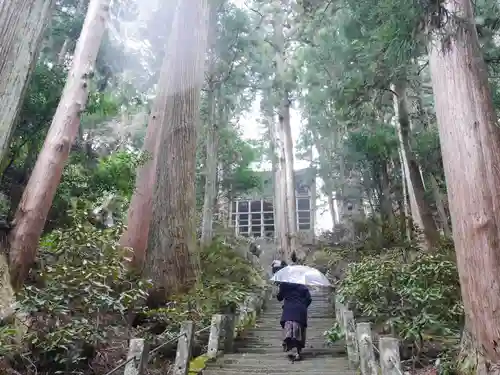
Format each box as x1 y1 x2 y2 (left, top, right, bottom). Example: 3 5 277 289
276 283 312 360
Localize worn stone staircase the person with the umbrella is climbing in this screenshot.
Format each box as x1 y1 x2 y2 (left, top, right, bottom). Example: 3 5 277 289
203 289 357 375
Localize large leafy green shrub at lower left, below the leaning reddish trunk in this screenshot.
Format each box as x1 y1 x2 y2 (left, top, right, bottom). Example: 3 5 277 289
0 209 149 374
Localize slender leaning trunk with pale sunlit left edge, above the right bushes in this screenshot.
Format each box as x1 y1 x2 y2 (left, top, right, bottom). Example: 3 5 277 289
392 80 439 250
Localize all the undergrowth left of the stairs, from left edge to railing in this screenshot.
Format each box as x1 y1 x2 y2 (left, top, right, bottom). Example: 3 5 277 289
0 207 263 375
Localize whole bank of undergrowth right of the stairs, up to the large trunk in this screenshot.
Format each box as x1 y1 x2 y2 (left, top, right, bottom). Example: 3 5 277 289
317 222 464 374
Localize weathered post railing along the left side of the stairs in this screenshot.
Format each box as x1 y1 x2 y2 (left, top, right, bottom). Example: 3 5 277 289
106 288 269 375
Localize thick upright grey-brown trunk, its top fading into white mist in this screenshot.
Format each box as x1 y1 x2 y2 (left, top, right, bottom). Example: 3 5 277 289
145 0 209 294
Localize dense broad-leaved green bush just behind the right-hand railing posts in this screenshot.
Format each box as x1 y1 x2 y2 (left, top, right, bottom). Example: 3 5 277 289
339 250 463 342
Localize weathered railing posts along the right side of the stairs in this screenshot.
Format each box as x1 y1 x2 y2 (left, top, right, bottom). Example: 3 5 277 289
335 298 403 375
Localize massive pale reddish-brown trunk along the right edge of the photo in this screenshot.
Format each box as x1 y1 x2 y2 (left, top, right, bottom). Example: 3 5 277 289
429 0 500 368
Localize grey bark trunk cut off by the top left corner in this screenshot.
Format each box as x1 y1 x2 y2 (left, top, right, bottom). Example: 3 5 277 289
0 0 55 165
